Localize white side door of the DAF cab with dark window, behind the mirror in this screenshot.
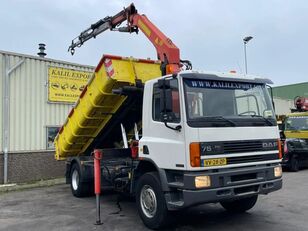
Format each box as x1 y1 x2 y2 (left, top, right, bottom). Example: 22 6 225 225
139 79 186 170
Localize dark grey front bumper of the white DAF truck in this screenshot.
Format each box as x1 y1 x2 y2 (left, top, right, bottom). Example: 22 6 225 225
165 165 282 210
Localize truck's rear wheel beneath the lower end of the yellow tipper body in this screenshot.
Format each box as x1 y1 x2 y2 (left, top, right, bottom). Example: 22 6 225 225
70 163 94 197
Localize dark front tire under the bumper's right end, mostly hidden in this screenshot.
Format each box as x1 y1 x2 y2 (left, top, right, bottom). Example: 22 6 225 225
220 195 258 213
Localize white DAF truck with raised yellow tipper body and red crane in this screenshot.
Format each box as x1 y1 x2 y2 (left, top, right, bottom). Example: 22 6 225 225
55 4 282 229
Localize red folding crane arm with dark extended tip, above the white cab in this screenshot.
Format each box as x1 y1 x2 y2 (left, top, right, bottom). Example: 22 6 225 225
68 3 192 75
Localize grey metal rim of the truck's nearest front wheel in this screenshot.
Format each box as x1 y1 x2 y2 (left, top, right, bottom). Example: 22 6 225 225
140 185 157 218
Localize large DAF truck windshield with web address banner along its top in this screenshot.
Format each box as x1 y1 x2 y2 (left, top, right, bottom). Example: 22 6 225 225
184 79 276 127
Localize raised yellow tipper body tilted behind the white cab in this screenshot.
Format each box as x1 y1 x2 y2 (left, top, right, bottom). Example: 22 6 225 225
55 55 161 160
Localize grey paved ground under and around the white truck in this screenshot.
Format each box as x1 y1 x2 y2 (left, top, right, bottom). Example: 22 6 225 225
0 170 308 231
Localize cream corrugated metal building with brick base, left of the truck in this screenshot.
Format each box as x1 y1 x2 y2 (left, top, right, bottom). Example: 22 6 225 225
0 51 94 183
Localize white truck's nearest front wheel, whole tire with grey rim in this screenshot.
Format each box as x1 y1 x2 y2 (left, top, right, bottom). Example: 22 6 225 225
136 172 170 229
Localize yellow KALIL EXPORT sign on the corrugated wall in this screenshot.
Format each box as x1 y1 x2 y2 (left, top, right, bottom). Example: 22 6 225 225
48 67 93 103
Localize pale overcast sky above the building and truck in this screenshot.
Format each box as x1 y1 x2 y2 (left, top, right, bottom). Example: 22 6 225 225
0 0 308 86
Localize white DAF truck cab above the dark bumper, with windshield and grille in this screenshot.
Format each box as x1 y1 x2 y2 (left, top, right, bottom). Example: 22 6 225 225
139 72 280 171
